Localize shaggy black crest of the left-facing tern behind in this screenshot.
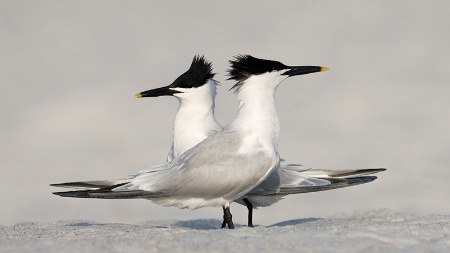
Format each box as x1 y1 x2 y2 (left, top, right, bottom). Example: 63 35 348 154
169 55 215 88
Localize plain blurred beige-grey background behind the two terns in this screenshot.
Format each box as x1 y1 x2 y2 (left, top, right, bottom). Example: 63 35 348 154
0 0 450 225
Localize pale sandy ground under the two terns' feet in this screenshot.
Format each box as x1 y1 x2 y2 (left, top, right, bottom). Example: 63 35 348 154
0 210 450 253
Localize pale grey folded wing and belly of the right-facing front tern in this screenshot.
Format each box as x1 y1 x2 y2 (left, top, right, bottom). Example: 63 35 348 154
120 131 278 203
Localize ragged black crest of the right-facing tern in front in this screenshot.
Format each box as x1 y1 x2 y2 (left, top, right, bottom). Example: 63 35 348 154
228 55 289 89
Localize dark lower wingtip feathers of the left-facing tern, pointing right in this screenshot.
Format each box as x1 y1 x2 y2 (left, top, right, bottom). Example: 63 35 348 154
274 176 377 195
